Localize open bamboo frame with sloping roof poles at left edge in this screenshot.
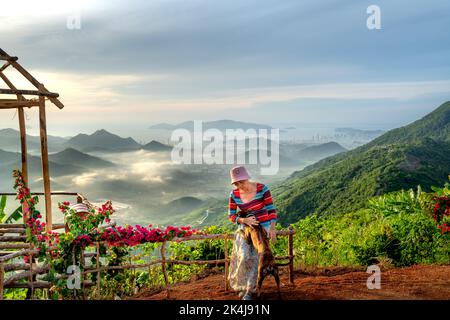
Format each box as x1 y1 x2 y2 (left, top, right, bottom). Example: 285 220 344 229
0 48 64 231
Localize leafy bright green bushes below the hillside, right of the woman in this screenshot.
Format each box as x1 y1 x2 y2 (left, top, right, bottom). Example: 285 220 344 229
288 187 450 267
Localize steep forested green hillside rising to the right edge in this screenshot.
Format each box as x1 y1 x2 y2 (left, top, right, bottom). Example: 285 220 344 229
273 102 450 224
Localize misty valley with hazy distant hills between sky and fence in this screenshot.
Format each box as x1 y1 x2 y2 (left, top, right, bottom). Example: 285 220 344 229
0 122 382 225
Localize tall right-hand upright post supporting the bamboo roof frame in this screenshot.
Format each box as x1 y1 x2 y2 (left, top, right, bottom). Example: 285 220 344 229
39 85 53 232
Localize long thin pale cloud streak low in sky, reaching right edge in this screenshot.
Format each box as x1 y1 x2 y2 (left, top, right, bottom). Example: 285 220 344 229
103 80 450 112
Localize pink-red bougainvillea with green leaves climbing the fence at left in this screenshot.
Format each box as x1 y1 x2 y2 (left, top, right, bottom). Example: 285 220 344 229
13 170 199 298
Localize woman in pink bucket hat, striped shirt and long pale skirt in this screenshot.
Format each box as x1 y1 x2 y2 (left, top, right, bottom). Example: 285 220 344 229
228 166 277 300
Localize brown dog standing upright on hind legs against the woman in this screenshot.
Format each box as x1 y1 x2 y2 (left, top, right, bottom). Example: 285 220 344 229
244 225 281 300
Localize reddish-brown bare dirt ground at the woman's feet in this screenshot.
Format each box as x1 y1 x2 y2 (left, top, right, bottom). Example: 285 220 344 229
133 265 450 300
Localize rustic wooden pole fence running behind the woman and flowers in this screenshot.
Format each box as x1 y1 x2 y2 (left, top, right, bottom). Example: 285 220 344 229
0 227 295 299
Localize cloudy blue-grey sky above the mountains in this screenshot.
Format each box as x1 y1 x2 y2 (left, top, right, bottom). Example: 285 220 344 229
0 0 450 136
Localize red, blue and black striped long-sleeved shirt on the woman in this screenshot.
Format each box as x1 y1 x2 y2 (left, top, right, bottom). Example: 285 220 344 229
228 183 277 229
